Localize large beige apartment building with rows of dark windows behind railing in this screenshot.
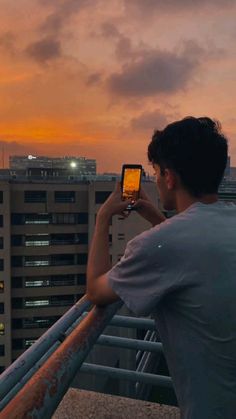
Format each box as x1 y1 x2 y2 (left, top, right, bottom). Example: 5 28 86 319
0 176 158 372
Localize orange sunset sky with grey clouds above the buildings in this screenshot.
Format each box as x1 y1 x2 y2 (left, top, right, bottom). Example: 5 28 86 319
0 0 236 173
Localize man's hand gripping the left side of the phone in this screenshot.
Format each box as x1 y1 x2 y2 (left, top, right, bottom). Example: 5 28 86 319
98 182 131 220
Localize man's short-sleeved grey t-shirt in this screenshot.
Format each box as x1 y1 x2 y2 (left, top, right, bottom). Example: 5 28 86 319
108 201 236 419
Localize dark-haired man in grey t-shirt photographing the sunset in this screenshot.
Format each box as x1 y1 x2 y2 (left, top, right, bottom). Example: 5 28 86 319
87 117 236 419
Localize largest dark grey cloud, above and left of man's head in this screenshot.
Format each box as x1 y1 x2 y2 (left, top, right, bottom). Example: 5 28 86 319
107 42 206 97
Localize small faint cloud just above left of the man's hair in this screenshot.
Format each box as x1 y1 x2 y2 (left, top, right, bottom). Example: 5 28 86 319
130 109 169 131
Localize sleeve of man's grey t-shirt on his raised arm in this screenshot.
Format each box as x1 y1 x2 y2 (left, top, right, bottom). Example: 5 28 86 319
107 231 172 315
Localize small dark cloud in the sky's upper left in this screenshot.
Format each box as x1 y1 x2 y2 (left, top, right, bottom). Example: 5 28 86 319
25 38 62 63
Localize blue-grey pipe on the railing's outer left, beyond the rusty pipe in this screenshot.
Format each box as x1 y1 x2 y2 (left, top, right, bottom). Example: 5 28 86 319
0 295 92 400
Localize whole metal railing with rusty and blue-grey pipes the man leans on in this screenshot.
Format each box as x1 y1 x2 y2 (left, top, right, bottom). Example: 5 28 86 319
0 296 172 419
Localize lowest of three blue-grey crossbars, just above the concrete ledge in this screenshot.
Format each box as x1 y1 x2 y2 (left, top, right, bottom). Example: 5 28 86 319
80 363 173 388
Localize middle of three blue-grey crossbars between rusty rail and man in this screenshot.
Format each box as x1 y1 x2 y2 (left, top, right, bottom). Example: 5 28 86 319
96 335 163 352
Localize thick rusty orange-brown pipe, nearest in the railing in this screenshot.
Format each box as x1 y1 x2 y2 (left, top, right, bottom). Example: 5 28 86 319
1 301 122 419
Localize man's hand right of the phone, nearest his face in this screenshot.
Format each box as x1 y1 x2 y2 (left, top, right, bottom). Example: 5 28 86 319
134 189 166 226
